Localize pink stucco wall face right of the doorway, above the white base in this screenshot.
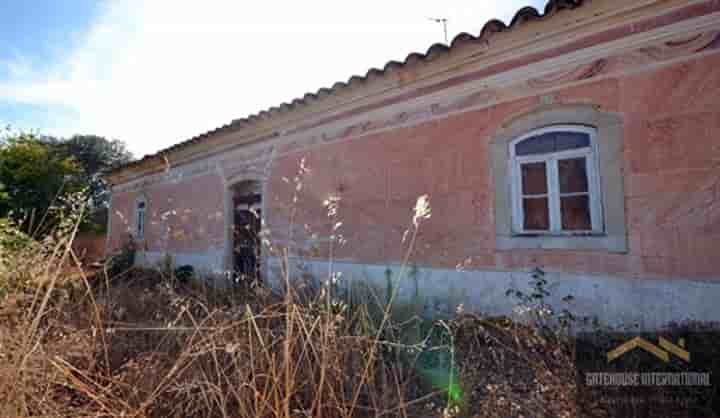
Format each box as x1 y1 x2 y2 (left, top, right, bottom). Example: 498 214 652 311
267 55 720 278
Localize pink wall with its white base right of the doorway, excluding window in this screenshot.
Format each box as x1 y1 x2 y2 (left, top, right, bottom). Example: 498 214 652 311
268 55 720 329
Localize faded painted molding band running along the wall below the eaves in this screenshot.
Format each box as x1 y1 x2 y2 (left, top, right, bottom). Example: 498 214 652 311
113 13 720 192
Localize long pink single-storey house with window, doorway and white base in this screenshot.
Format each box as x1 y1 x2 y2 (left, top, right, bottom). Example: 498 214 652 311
108 0 720 328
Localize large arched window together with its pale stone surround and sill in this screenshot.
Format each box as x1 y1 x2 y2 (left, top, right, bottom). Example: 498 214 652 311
488 103 628 253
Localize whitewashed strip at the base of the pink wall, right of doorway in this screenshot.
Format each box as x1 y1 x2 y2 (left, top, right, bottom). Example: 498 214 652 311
268 259 720 330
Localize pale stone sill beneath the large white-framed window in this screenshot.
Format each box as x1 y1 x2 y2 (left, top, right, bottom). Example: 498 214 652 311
495 233 627 253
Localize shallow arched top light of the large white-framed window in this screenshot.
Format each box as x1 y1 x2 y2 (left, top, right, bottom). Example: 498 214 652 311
511 125 595 157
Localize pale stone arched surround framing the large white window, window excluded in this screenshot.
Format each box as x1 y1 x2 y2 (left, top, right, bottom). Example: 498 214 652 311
490 105 628 253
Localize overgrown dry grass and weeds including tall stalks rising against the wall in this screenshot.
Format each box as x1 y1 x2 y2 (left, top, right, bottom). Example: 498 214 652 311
5 155 716 418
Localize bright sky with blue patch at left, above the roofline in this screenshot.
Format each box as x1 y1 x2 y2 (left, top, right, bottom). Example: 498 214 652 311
0 0 544 156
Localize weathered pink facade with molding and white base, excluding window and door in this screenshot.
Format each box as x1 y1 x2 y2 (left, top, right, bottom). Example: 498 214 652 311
109 2 720 328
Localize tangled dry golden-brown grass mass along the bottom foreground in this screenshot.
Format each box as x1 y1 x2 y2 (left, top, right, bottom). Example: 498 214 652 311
0 229 572 417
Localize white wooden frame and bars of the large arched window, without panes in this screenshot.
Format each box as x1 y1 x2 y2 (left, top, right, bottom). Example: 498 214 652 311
509 125 604 235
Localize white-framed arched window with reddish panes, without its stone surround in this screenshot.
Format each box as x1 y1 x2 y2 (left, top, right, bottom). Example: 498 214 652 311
510 125 603 235
